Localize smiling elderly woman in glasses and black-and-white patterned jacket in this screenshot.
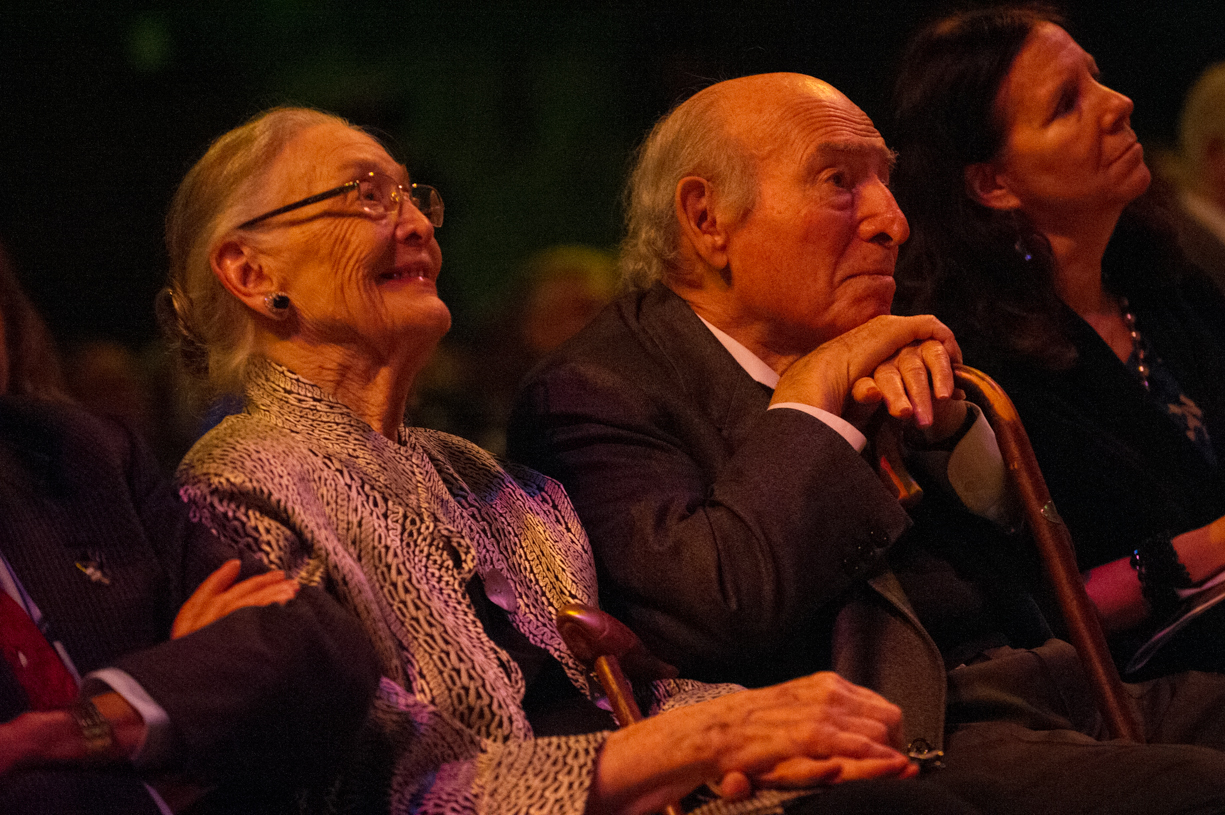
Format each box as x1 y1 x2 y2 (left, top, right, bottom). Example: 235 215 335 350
167 108 989 813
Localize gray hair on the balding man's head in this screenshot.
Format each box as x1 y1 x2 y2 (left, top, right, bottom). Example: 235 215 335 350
620 88 756 289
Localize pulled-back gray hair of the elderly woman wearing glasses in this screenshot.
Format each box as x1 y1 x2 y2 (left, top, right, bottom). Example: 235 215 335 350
158 108 352 391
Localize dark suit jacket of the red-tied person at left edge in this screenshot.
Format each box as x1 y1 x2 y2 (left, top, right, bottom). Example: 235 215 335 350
0 397 377 811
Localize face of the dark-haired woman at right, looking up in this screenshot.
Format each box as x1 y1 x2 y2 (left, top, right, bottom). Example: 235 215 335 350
993 23 1150 228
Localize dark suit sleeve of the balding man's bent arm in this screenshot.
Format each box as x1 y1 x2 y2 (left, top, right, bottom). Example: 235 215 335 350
510 363 909 684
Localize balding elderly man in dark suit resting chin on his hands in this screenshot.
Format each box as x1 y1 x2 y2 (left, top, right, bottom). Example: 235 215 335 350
510 74 1225 814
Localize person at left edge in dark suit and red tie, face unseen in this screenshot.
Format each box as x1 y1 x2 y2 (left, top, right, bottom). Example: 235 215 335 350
0 252 377 815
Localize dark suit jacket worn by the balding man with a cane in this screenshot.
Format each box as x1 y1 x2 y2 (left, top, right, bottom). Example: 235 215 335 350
510 286 1053 744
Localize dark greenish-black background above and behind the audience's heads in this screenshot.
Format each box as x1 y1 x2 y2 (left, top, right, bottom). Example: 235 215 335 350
0 0 1225 346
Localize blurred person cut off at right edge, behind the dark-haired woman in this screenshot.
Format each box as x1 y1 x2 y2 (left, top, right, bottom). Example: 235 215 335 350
1172 63 1225 290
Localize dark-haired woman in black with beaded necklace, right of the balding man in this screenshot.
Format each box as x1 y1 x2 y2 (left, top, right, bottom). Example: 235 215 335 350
894 7 1225 670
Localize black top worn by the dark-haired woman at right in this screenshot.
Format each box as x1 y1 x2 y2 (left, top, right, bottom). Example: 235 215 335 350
936 265 1225 674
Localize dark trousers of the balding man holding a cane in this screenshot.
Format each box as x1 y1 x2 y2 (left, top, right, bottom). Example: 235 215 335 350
926 641 1225 815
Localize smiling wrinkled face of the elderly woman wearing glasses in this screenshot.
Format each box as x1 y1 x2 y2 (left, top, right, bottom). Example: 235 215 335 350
257 123 451 363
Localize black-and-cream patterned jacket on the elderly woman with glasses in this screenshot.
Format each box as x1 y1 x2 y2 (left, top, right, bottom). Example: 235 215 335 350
179 362 790 815
